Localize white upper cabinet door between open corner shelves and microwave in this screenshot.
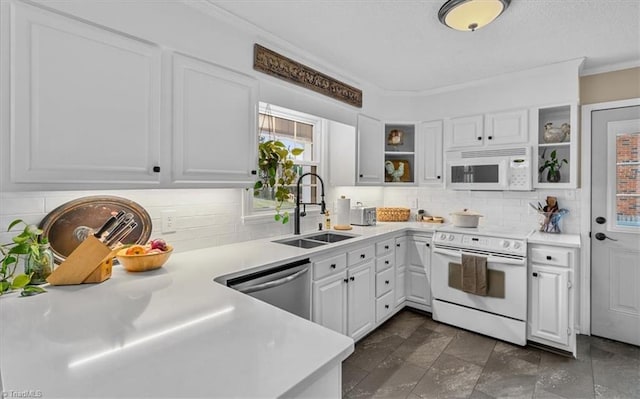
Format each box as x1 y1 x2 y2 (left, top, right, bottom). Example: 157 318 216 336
418 121 444 185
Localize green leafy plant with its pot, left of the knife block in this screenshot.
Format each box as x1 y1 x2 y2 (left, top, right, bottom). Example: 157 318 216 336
0 219 54 296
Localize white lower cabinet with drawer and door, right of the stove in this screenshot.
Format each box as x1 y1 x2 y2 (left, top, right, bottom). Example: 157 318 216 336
527 245 577 356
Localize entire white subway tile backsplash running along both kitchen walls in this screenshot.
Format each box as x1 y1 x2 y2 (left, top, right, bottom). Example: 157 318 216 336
0 187 580 258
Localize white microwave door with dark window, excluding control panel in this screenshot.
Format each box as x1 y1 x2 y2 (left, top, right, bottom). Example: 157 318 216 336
447 158 509 190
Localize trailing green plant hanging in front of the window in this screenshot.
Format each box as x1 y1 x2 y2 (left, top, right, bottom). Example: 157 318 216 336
253 140 304 224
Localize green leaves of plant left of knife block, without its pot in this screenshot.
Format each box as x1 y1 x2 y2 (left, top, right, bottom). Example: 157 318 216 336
0 219 48 296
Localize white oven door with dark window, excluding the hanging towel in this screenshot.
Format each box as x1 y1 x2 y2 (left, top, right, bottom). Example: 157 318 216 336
431 247 527 320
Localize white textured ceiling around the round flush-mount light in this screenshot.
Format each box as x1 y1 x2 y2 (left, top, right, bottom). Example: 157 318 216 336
207 0 640 92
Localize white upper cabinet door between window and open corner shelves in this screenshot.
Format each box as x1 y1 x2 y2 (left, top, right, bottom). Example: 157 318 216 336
356 115 384 184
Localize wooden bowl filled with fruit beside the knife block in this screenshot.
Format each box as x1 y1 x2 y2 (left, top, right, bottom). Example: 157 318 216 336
116 239 173 272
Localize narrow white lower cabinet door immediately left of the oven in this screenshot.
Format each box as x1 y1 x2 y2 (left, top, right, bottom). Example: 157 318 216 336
406 236 431 311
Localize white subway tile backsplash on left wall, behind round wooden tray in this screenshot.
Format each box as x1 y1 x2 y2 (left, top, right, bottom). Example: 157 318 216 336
0 189 321 251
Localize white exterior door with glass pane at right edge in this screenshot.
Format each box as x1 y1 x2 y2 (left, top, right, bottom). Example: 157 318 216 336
591 106 640 345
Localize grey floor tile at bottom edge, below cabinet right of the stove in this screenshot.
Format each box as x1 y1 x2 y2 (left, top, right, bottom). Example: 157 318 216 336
536 352 594 398
